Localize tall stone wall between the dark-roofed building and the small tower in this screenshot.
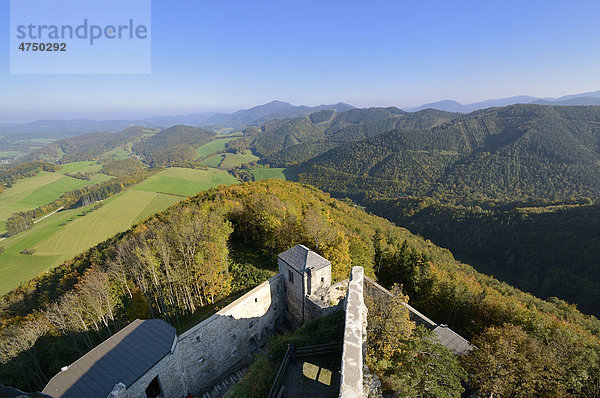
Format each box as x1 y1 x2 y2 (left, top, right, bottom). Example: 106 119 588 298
119 274 285 398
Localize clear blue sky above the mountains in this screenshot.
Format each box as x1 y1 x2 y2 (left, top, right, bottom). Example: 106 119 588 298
0 0 600 121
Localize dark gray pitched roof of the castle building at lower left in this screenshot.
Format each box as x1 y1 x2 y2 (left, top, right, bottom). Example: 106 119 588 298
43 319 176 398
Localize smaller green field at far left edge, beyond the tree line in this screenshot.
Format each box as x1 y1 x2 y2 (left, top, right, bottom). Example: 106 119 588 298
0 171 111 233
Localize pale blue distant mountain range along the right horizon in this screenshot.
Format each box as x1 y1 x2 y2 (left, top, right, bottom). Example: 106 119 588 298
404 91 600 113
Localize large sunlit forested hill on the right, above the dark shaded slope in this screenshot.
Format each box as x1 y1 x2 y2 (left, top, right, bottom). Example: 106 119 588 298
299 105 600 203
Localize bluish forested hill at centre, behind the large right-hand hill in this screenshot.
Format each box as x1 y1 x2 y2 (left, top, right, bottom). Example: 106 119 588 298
252 107 459 165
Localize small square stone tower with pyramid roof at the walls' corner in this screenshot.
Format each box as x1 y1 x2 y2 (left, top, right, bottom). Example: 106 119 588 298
277 245 331 328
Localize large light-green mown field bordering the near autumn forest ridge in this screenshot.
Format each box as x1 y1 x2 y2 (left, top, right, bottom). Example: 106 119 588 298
0 166 237 295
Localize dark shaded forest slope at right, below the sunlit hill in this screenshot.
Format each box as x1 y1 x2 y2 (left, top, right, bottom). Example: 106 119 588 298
368 198 600 316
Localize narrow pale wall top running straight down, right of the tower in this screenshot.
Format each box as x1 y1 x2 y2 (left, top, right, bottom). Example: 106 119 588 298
339 267 367 398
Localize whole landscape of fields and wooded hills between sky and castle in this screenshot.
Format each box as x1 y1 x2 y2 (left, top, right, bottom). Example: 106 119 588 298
0 105 600 391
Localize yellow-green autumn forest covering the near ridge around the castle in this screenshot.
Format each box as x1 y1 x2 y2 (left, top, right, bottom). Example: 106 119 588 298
0 180 600 397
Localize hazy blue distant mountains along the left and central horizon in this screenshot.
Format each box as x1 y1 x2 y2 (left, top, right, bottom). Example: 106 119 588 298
0 101 354 139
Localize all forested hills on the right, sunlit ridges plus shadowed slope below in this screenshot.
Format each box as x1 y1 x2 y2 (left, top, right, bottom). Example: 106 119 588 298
239 105 600 314
